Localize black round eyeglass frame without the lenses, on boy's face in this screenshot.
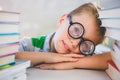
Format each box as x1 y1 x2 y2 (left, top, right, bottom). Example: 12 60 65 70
68 15 96 56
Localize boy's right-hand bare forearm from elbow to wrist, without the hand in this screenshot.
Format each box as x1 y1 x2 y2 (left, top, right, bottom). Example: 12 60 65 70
74 52 111 69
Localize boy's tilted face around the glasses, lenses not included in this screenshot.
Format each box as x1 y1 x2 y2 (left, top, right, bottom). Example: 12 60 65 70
52 14 97 54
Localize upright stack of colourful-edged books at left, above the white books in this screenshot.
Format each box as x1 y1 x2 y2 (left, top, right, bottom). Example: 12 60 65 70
0 11 20 69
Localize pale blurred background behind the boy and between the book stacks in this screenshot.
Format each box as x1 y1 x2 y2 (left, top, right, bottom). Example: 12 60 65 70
0 0 120 37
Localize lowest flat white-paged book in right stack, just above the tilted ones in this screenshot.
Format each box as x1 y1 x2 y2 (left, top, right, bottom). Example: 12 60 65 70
105 28 120 40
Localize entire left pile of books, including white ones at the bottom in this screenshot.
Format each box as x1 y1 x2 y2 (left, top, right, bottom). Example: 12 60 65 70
0 11 30 80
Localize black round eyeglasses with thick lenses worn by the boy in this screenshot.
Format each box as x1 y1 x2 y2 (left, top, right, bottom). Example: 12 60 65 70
68 15 95 56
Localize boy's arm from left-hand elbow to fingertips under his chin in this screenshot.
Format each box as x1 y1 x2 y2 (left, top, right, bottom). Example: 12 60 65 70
16 52 83 65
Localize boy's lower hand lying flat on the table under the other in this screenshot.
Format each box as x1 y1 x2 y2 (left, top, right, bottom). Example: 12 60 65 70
35 62 75 70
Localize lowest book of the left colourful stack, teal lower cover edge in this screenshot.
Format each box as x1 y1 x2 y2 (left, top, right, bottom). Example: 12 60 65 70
0 54 15 68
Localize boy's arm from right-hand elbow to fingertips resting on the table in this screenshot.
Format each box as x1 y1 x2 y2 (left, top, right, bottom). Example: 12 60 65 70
36 52 111 70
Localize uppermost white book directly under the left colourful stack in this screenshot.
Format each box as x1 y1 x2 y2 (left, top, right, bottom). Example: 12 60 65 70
0 60 30 80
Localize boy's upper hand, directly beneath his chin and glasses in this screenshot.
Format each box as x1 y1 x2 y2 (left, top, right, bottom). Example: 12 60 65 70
44 53 84 63
